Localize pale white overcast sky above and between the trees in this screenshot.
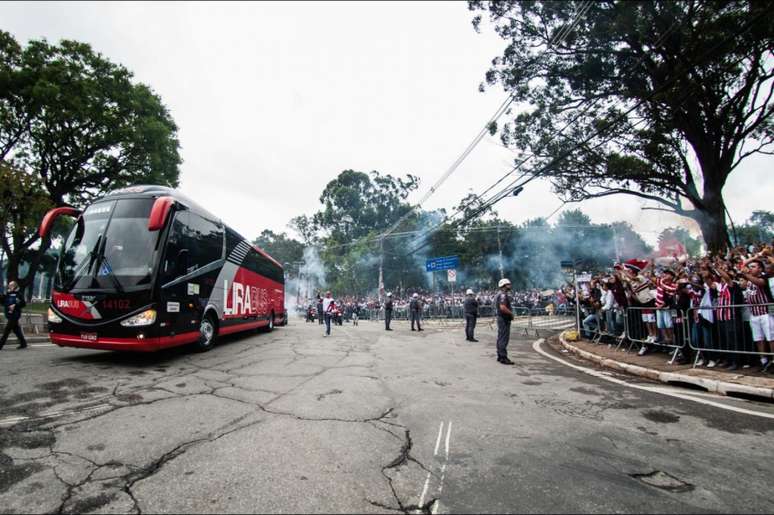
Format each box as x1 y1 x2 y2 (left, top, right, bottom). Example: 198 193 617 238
0 2 774 248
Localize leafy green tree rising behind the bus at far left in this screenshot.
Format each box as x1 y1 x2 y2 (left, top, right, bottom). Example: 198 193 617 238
0 31 181 287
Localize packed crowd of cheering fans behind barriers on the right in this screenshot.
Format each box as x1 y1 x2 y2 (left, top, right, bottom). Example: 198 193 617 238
579 244 774 372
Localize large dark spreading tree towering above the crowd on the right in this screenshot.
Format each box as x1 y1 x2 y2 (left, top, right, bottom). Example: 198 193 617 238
469 0 774 250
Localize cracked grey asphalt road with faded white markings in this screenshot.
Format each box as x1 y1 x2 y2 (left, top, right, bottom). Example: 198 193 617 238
0 320 774 513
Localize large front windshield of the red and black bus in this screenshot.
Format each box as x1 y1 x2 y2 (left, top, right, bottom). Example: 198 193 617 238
56 198 161 291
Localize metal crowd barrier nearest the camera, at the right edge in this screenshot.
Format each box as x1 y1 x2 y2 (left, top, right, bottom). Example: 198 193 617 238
686 303 774 366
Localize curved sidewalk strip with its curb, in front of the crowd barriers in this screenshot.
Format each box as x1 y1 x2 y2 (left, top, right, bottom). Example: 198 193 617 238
558 333 774 399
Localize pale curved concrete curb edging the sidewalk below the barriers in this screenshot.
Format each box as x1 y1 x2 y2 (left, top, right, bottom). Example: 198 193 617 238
559 334 774 400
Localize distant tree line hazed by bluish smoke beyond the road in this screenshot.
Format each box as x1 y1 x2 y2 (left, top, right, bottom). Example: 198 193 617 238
278 170 652 295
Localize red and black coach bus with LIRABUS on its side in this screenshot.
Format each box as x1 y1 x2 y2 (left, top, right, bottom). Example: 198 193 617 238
39 186 287 351
